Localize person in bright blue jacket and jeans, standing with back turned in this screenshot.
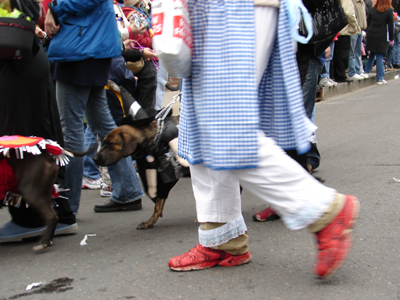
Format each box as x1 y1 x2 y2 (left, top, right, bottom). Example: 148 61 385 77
45 0 143 214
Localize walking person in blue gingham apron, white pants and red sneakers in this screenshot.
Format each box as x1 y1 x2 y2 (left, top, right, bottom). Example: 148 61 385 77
168 0 359 278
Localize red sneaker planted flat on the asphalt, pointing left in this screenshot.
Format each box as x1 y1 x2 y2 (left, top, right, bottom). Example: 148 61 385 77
168 244 251 271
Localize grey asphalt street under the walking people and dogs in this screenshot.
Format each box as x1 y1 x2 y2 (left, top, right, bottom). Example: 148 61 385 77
0 80 400 300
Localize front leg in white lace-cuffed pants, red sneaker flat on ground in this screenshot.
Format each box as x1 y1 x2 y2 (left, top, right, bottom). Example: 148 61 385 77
168 164 251 271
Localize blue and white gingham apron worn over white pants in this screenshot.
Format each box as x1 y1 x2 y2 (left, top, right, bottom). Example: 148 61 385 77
178 0 310 170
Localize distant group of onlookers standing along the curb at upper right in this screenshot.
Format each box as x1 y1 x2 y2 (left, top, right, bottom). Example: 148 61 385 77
319 0 400 87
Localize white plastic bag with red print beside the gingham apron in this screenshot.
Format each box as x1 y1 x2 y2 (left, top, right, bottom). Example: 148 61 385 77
152 0 193 78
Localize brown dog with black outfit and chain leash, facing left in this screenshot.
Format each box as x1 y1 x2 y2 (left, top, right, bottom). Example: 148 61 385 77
93 116 188 229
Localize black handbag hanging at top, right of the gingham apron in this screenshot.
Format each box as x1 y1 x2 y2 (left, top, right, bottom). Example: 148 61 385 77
299 0 348 44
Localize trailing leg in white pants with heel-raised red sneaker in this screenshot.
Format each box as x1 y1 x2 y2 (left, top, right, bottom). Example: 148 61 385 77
230 132 359 278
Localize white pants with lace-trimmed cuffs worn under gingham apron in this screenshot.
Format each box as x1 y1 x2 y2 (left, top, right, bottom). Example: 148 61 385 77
190 7 336 235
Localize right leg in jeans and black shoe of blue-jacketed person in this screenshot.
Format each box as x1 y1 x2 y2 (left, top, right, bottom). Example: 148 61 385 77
86 87 144 212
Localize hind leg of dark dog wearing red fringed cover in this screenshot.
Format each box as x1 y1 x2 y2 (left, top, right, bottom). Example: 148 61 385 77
12 153 58 251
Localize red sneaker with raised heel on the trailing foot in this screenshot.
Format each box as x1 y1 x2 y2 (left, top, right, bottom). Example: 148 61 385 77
314 196 360 278
